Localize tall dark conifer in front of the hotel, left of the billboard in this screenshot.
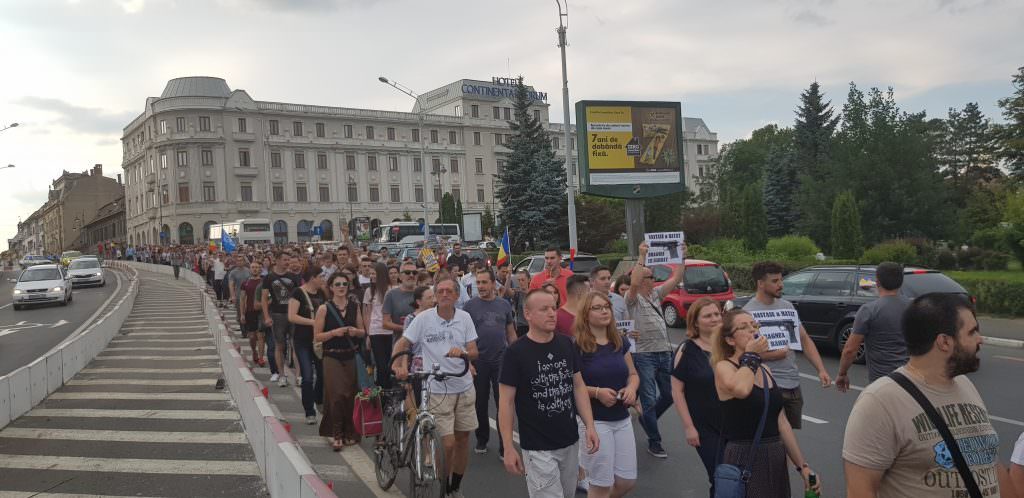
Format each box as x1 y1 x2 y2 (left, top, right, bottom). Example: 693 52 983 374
498 77 566 249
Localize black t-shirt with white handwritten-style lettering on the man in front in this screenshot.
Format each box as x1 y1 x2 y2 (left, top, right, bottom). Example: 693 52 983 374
497 334 582 451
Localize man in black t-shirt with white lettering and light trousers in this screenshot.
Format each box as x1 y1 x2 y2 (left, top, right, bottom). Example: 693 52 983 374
498 289 600 497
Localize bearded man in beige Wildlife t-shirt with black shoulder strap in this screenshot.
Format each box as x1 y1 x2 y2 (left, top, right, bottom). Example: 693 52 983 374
843 293 1009 498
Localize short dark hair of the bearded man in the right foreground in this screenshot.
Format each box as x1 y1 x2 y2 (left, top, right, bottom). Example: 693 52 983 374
903 292 974 357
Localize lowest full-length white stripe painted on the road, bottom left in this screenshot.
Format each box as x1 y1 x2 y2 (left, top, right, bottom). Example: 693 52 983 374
0 455 260 476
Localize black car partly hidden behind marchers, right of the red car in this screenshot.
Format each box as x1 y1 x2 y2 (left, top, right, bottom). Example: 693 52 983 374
733 265 974 363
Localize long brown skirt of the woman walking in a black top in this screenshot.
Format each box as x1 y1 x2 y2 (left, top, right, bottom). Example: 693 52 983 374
319 355 359 441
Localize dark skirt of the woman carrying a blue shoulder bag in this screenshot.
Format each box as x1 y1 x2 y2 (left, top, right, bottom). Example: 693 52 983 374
722 437 790 498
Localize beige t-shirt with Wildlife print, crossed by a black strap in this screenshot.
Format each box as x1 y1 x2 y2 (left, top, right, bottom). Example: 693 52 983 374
843 367 999 498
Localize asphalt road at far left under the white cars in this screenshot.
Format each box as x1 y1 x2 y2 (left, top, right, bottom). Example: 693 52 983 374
0 271 119 375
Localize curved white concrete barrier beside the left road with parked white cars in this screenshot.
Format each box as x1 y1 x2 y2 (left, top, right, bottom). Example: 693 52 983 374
0 261 138 429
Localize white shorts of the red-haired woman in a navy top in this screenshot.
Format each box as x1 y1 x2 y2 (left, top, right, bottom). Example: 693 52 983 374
577 417 637 488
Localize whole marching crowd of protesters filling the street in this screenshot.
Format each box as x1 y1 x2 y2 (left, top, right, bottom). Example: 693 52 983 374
124 234 1024 498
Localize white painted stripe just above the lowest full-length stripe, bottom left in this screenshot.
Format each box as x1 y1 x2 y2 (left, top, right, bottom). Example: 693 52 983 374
0 427 248 445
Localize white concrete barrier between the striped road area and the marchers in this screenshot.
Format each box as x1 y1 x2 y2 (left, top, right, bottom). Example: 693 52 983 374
122 262 336 498
